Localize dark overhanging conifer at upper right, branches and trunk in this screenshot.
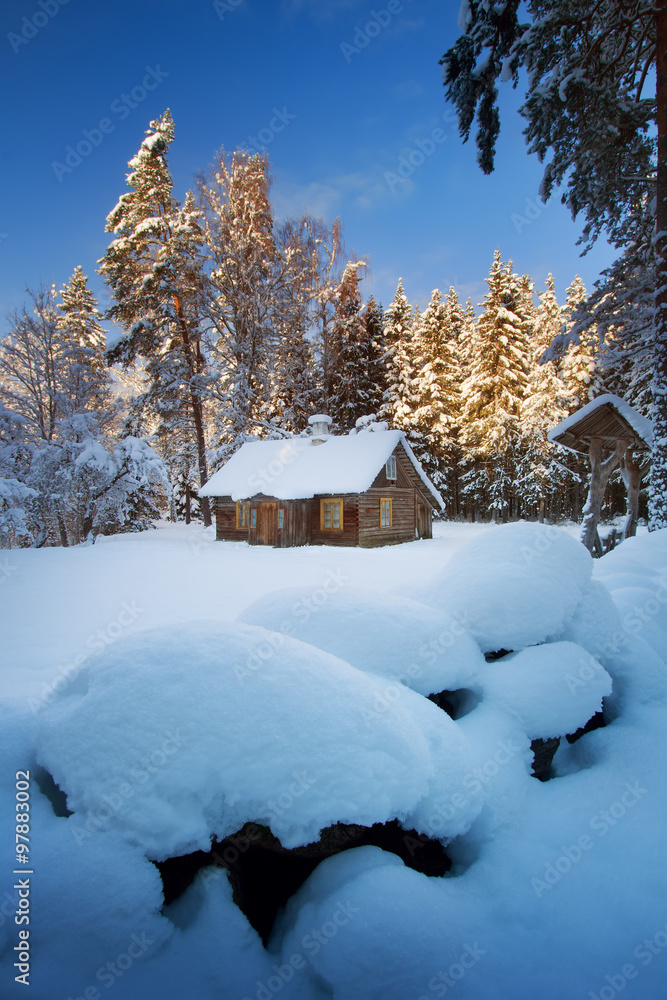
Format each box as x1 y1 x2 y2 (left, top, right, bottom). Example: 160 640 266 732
441 0 667 528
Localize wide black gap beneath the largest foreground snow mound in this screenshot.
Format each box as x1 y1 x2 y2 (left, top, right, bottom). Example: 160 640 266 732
154 820 451 944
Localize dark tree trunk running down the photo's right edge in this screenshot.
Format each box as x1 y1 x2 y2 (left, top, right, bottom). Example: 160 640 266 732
649 0 667 531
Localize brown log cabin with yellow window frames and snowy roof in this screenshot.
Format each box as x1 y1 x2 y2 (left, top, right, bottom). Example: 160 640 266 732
200 416 443 548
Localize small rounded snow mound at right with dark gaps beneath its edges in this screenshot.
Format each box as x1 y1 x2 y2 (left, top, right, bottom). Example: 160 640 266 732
483 642 611 739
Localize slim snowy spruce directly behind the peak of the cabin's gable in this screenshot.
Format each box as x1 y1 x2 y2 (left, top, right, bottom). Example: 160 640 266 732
379 278 415 436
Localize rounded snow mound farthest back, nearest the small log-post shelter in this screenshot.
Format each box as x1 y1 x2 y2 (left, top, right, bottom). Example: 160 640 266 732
420 523 592 652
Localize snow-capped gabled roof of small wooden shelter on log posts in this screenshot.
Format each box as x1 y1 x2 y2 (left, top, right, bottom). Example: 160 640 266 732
547 393 653 453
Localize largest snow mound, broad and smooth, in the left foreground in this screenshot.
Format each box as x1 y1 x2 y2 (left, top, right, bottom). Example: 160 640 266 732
37 622 481 860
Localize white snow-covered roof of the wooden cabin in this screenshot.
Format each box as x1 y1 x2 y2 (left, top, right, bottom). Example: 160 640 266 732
199 431 444 507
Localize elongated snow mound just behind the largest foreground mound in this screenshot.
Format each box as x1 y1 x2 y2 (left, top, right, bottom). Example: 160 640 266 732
238 587 485 695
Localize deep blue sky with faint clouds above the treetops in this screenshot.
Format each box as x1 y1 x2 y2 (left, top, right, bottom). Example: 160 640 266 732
0 0 612 316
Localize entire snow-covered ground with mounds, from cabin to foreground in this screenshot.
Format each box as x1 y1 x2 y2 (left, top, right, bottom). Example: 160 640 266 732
0 524 667 1000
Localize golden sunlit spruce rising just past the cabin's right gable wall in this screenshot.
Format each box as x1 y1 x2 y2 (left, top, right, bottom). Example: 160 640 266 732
412 288 463 513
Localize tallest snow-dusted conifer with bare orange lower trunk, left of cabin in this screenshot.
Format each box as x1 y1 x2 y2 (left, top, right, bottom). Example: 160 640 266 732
100 110 211 525
